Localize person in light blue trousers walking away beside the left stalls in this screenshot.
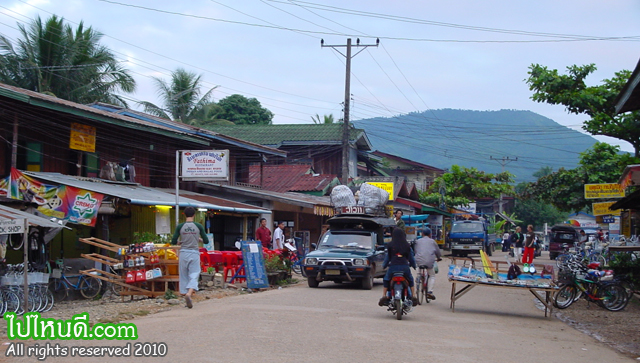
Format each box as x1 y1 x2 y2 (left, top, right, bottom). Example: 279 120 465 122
171 207 208 309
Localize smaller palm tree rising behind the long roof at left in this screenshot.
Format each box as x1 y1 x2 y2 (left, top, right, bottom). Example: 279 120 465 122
140 68 218 123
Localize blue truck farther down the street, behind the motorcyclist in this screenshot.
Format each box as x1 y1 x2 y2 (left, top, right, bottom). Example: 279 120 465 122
449 220 494 257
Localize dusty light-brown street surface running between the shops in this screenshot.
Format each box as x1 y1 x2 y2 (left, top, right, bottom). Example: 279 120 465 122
5 264 636 363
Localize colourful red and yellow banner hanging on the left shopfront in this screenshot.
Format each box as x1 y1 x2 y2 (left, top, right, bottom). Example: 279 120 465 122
0 168 104 227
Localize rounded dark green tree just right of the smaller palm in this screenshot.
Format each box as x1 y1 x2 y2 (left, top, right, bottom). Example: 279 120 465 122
218 94 273 125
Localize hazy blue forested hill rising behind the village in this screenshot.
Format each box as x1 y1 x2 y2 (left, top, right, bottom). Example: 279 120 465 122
353 109 597 182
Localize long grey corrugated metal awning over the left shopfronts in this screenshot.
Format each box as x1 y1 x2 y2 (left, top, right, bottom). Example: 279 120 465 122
23 171 271 214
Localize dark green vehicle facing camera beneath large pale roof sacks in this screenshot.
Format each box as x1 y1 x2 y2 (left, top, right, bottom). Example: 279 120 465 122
302 207 396 290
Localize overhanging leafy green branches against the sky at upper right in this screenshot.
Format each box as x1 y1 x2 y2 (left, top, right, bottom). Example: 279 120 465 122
527 64 640 157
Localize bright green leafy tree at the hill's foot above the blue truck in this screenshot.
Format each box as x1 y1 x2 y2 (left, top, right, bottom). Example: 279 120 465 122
420 165 513 207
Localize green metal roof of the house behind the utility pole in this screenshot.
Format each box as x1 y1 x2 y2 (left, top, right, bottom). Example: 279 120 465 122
211 124 370 147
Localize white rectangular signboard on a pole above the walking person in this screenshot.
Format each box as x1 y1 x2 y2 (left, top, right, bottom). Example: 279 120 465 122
180 150 229 181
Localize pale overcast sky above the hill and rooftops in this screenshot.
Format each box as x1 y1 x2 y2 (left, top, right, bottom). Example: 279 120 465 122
0 0 640 151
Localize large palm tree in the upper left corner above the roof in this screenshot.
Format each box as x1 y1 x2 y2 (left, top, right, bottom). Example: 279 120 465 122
0 15 136 107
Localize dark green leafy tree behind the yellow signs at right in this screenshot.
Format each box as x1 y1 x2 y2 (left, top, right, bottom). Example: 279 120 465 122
521 142 638 212
